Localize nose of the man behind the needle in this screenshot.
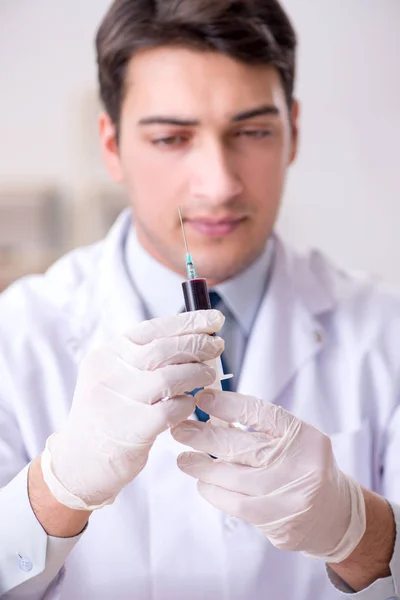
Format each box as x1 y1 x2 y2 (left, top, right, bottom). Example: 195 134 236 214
190 141 243 205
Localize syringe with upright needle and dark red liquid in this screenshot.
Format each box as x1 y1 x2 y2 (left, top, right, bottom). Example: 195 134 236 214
178 206 233 390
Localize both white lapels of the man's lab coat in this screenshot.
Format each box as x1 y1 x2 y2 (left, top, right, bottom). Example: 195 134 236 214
68 210 338 401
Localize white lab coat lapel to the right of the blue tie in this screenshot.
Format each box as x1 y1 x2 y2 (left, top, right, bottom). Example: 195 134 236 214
238 238 332 402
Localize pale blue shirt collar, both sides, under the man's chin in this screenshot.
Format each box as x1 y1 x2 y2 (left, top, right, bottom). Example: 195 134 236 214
125 227 274 335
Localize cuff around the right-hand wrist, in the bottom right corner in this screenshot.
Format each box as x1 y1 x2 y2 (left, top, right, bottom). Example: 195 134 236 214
326 504 400 600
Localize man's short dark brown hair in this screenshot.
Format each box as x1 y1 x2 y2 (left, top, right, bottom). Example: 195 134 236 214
96 0 296 129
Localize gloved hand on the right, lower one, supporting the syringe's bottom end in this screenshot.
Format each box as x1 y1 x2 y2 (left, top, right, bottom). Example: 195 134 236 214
172 390 366 563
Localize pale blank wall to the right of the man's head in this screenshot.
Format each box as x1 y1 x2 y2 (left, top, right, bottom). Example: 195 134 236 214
281 0 400 282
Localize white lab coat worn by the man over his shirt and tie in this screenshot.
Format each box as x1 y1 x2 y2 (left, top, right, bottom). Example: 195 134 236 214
0 213 400 600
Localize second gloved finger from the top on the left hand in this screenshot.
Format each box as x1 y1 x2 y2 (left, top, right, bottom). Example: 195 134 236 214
111 333 225 371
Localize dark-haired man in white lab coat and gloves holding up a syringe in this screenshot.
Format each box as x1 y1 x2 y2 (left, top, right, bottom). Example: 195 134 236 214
0 0 400 600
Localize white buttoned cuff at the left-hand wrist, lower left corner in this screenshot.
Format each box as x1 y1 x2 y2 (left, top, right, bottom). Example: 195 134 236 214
0 465 82 600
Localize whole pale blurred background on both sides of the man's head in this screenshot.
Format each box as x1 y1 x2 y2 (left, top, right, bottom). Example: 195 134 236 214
0 0 400 287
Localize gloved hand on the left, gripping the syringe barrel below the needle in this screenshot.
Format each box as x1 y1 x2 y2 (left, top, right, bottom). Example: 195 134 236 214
41 310 224 510
